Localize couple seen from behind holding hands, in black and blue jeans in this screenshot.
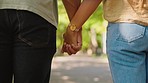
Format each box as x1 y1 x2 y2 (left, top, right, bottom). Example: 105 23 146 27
0 0 148 83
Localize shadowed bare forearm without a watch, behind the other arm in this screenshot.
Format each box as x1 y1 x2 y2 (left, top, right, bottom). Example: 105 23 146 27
62 0 81 21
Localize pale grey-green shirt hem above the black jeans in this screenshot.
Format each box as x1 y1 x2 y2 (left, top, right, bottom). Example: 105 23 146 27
0 0 58 26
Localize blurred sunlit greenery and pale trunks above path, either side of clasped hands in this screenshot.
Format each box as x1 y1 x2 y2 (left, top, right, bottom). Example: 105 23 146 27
57 0 107 56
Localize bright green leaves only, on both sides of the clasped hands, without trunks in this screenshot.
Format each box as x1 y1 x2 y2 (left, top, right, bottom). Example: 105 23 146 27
57 0 106 50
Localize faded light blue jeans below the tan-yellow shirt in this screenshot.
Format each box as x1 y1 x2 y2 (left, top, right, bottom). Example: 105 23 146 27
107 23 148 83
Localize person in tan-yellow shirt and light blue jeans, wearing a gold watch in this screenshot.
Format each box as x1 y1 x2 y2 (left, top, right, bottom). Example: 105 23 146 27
63 0 148 83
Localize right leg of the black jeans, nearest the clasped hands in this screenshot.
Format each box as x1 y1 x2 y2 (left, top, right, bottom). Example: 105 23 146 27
14 11 56 83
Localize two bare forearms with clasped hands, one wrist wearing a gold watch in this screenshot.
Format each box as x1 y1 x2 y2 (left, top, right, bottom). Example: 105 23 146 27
62 0 101 55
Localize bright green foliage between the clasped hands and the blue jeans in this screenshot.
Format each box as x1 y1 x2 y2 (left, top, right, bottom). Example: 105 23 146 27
83 4 105 49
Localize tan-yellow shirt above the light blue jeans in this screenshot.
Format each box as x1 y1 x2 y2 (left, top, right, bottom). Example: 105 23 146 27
103 0 148 26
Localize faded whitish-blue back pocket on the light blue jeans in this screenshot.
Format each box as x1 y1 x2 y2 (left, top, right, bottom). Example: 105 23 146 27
117 23 145 42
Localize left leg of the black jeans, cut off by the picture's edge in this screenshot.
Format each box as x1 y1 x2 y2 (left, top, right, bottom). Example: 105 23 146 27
0 10 13 83
